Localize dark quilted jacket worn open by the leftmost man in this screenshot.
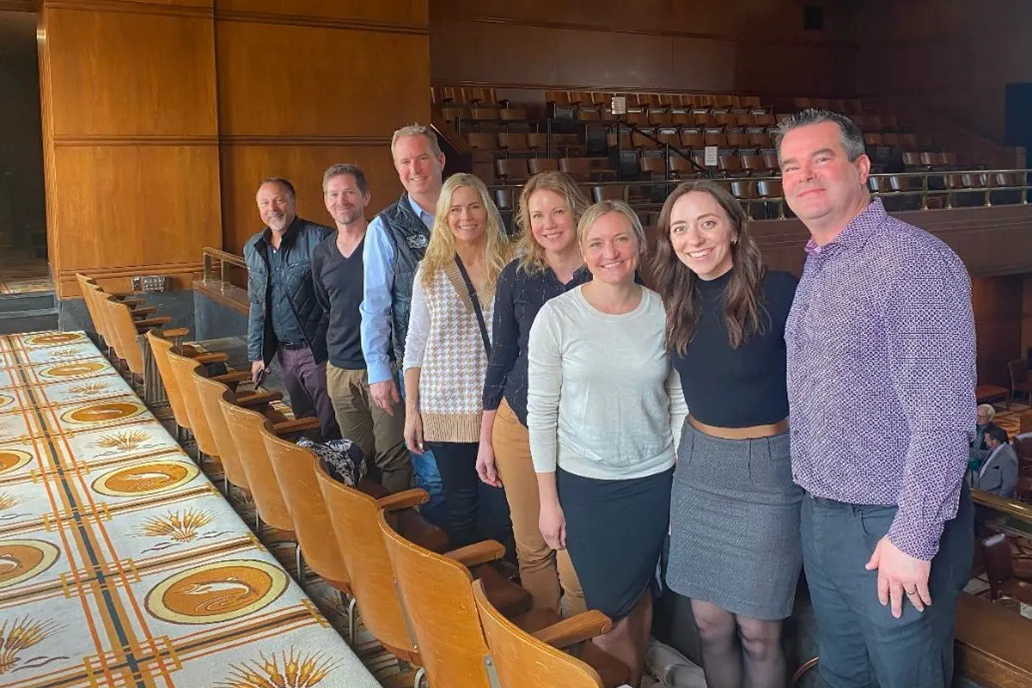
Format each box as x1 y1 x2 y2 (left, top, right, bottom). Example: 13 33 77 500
244 218 332 365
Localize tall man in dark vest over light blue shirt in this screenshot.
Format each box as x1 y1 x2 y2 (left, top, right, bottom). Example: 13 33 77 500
361 124 445 523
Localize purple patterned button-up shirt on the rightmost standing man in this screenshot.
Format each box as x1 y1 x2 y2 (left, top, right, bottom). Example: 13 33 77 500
784 199 976 560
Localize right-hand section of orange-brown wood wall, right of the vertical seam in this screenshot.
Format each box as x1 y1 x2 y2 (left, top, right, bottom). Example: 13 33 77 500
215 0 430 253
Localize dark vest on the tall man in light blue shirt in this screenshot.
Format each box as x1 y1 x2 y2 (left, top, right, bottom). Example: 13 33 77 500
380 193 430 364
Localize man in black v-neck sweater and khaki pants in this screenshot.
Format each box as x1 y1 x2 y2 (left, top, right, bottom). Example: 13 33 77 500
312 164 412 492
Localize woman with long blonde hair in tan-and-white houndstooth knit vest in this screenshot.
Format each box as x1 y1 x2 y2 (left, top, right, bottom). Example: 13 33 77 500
404 173 515 560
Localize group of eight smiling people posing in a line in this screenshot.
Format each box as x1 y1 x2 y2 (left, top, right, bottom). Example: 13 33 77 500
246 110 975 688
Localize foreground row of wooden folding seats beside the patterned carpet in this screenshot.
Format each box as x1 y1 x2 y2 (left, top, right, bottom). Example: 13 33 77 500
149 305 630 688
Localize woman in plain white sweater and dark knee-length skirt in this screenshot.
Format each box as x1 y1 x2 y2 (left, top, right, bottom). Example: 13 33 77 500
527 201 687 686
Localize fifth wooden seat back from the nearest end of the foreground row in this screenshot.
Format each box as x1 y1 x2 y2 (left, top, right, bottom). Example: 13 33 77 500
219 390 294 530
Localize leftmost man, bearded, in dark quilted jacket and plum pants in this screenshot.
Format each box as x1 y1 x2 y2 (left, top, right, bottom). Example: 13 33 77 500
244 177 341 439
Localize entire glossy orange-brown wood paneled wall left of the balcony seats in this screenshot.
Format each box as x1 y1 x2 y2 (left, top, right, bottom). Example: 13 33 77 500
39 0 430 297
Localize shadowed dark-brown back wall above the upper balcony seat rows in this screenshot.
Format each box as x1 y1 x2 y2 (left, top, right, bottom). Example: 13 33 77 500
430 0 856 96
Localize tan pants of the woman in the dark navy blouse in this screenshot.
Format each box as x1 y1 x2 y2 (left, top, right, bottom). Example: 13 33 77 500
491 401 585 616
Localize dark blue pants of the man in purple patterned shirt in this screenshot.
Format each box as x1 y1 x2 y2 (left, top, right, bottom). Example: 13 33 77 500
801 485 974 688
